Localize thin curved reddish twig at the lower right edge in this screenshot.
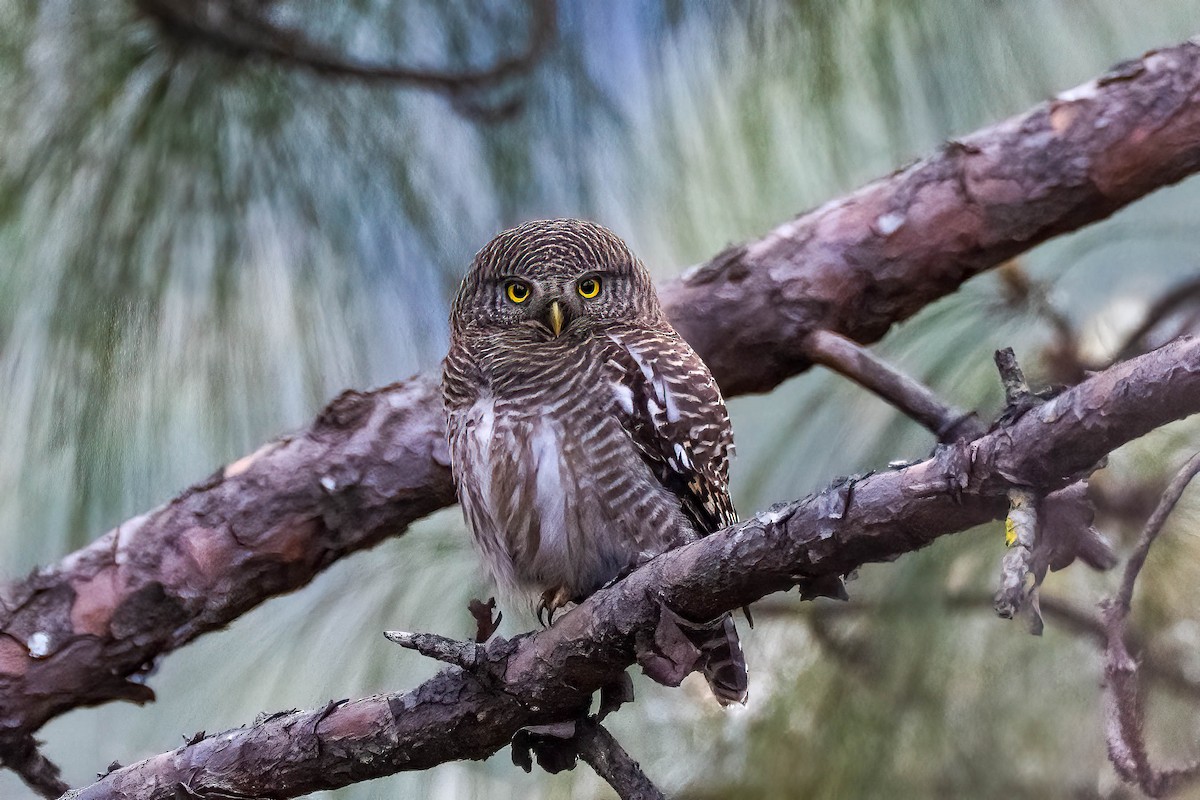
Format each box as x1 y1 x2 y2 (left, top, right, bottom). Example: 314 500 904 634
1103 453 1200 798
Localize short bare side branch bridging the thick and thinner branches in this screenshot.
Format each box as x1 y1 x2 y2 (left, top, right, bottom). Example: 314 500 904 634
804 330 984 443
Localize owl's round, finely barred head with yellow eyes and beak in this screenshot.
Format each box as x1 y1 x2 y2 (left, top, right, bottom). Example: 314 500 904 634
450 219 662 338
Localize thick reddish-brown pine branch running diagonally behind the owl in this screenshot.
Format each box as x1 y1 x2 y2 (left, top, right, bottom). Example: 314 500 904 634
0 38 1200 748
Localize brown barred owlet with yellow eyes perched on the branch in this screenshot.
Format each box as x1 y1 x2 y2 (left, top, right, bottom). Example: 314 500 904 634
442 219 746 704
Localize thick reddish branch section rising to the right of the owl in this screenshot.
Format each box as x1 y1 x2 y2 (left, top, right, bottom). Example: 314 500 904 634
665 42 1200 393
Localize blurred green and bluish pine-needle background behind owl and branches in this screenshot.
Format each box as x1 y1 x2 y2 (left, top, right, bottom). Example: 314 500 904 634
0 0 1200 800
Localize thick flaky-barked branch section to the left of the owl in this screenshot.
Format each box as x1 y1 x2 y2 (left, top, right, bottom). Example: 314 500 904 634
0 378 454 742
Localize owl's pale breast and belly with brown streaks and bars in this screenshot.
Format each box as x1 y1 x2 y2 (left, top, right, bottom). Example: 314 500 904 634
451 369 694 597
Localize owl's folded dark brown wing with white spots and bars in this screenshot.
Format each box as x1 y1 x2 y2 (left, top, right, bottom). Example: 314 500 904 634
610 330 737 534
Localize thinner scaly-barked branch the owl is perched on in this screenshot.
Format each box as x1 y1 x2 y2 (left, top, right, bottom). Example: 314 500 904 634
63 338 1200 800
